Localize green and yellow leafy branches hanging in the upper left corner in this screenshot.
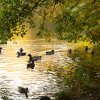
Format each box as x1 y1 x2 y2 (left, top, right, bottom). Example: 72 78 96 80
0 0 41 43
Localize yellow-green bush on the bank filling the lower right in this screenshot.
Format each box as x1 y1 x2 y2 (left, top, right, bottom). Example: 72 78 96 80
49 44 100 100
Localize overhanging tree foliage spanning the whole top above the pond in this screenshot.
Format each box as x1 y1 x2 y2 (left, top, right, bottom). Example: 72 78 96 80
0 0 100 43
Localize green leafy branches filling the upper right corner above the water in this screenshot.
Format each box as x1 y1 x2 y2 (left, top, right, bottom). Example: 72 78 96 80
56 0 100 42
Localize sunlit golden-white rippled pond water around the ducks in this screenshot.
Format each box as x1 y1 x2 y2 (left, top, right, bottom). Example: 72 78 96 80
0 40 71 100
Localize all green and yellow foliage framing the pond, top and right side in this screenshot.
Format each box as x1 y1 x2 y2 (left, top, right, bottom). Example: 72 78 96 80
0 0 100 100
